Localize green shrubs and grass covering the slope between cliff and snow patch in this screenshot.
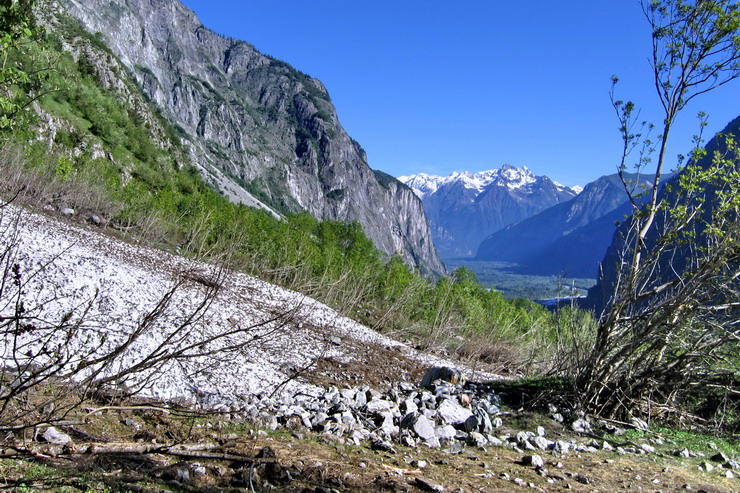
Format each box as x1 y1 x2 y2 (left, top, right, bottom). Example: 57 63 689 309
0 0 737 440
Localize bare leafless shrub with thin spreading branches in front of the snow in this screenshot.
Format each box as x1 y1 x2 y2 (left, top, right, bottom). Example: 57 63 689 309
0 201 310 429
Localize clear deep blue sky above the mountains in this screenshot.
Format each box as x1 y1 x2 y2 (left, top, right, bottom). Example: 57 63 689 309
176 0 740 186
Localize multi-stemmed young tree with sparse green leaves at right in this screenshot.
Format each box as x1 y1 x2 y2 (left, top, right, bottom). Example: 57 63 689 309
578 0 740 417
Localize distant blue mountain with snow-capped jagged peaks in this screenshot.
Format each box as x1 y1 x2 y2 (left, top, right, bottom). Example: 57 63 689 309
399 165 576 258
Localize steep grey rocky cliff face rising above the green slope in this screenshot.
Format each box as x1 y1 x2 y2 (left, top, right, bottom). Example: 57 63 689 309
60 0 444 272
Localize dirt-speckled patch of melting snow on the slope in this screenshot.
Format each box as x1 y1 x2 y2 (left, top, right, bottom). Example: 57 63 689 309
0 206 495 407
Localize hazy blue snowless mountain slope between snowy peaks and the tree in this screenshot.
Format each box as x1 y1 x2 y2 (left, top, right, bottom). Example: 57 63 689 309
476 174 637 277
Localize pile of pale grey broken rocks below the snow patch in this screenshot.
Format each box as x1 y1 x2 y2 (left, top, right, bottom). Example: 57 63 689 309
240 367 503 451
